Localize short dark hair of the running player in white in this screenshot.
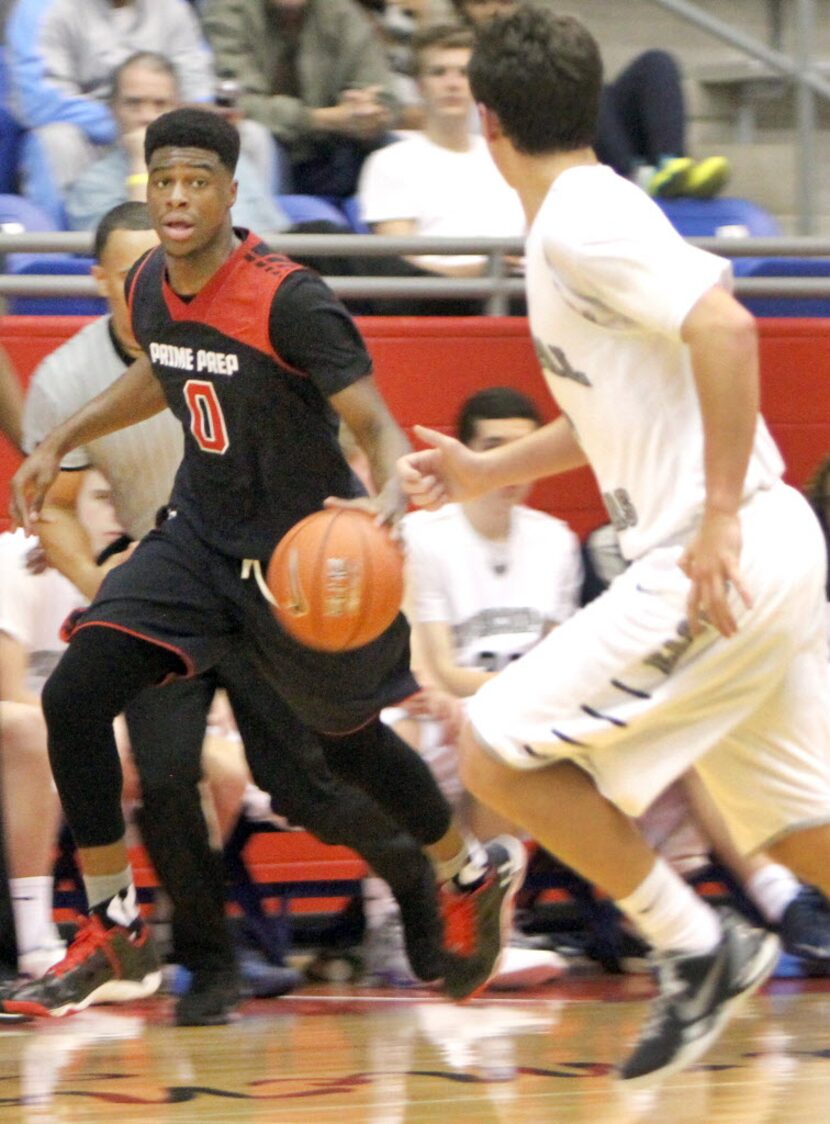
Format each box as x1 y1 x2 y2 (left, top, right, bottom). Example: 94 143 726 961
468 4 603 155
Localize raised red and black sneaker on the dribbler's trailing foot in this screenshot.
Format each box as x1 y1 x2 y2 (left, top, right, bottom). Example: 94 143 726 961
441 835 527 999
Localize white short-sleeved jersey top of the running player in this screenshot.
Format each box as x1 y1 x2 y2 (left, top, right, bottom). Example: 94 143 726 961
526 165 784 559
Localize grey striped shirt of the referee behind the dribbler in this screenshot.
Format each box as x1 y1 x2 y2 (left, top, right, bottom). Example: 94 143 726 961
22 316 183 538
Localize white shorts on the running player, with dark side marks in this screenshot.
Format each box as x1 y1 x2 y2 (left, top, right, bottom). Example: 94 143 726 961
468 483 830 851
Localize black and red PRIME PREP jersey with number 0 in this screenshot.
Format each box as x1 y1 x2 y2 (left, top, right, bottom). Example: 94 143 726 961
126 232 371 560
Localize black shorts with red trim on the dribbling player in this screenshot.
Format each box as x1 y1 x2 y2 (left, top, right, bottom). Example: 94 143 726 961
65 514 417 734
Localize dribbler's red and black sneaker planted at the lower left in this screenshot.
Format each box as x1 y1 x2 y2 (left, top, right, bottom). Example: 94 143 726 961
0 914 162 1019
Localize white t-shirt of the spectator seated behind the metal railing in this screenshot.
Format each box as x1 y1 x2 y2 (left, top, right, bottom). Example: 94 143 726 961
358 133 525 269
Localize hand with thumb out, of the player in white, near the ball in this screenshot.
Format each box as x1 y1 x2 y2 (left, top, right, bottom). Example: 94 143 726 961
397 425 487 511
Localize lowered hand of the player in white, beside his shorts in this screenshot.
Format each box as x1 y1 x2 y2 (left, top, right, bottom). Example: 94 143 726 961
679 509 752 636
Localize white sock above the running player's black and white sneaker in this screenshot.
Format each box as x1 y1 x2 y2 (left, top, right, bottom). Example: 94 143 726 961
616 859 721 955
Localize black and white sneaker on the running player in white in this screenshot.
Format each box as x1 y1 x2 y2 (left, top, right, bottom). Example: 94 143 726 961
620 914 779 1084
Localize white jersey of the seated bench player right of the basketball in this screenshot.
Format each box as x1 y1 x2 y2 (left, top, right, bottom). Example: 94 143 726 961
402 504 583 671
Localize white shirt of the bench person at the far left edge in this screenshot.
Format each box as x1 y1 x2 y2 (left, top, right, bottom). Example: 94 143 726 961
0 531 87 695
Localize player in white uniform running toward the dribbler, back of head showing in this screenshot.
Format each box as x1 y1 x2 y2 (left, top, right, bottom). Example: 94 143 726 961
400 8 830 1081
